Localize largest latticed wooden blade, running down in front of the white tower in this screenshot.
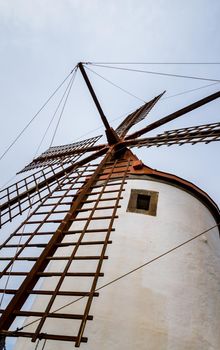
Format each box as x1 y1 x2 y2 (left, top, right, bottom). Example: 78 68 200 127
0 149 131 347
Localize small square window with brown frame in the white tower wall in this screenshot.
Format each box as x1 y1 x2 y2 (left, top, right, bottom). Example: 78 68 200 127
127 189 159 216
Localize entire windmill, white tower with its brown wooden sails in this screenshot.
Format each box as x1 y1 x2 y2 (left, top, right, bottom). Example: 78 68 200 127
0 63 220 350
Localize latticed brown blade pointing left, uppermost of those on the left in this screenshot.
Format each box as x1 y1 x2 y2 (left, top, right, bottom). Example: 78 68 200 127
19 135 103 173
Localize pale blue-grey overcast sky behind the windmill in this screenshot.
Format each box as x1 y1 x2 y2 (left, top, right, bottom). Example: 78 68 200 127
0 0 220 208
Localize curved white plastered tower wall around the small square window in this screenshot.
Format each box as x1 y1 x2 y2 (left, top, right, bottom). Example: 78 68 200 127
16 176 220 350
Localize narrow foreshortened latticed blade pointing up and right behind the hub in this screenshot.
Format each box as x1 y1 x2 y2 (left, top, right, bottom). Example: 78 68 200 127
116 91 165 137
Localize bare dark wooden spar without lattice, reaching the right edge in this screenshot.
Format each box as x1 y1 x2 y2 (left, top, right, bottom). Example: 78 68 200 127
125 91 220 140
